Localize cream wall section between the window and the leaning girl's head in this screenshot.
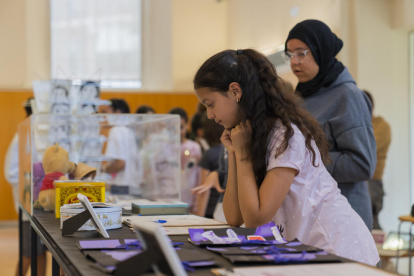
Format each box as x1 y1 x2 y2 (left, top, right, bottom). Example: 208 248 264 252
172 0 229 91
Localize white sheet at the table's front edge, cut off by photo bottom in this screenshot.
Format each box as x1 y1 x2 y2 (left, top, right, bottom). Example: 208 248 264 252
233 263 390 276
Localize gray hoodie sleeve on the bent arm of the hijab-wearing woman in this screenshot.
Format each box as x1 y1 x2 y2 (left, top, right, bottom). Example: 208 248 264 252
325 90 377 183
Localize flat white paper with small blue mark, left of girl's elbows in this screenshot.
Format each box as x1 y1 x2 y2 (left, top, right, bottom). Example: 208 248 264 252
128 215 227 228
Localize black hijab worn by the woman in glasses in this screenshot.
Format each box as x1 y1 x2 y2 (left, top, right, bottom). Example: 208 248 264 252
285 19 345 98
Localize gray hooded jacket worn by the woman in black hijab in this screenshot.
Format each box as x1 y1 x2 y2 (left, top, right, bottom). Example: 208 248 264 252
304 68 377 230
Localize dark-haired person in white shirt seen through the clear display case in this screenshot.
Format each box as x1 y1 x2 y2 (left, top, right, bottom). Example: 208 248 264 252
100 98 140 195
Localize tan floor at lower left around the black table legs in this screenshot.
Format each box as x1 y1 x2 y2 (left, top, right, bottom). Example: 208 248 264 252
0 223 52 276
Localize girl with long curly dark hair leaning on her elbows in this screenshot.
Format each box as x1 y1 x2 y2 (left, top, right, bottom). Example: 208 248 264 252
194 49 379 265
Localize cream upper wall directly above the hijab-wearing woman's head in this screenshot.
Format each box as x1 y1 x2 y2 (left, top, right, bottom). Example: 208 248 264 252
228 0 341 51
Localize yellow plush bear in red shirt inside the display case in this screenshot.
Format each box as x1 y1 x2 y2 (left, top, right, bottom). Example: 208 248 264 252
38 143 76 211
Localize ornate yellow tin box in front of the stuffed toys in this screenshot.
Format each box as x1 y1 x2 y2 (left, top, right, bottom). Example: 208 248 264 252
53 180 105 218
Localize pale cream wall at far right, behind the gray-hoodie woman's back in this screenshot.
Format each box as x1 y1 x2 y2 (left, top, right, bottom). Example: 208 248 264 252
354 0 411 231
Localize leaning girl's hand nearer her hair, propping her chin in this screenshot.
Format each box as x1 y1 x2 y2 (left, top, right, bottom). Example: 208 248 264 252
231 120 252 159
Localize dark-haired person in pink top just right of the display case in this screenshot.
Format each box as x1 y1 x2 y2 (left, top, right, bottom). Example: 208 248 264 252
169 107 202 212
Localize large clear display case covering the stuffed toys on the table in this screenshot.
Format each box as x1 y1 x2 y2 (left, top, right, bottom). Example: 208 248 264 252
18 114 180 215
